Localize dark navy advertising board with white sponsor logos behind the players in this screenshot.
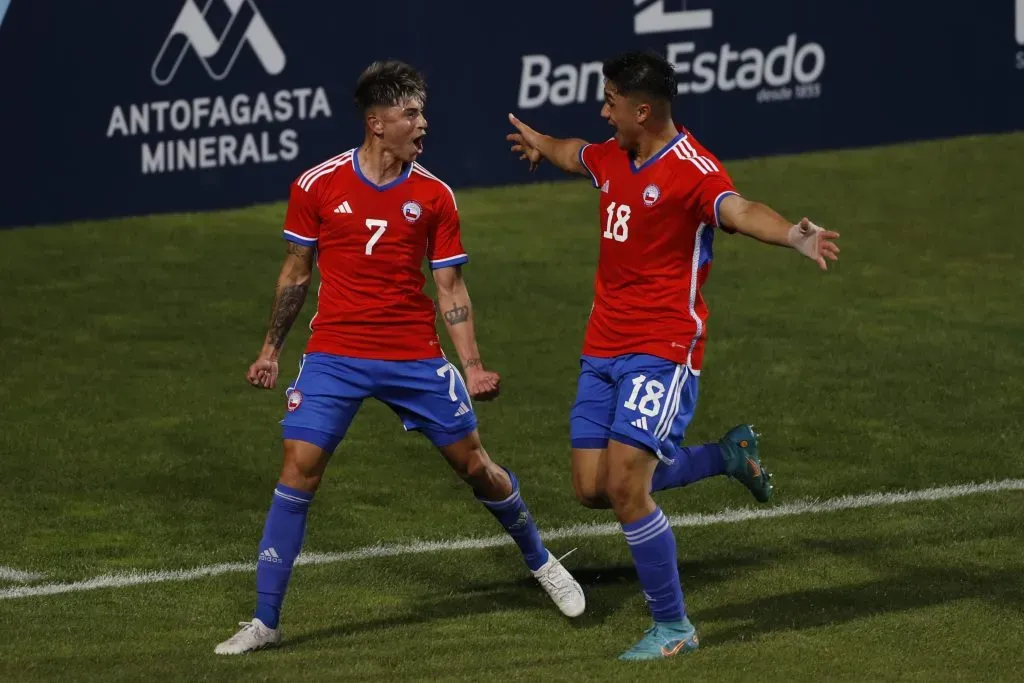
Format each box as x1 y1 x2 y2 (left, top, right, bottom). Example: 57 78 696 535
0 0 1024 226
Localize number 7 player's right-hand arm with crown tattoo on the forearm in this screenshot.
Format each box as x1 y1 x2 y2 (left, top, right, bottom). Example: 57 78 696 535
434 266 501 400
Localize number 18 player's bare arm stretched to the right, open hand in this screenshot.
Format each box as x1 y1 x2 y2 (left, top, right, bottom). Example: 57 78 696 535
719 195 839 270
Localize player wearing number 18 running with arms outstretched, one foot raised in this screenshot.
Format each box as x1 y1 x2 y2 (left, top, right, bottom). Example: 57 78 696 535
508 52 839 659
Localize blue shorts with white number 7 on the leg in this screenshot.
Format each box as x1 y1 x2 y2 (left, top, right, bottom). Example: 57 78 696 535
281 353 476 453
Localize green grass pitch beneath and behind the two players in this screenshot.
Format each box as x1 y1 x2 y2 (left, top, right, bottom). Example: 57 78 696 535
0 134 1024 681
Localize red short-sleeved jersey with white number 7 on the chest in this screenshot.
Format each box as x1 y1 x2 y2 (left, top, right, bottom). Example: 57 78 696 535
285 150 469 360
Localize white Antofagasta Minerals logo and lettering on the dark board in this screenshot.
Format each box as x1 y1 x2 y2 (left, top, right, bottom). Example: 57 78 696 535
106 0 331 174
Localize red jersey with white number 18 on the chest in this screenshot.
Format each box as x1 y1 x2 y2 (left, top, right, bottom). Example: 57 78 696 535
580 130 736 374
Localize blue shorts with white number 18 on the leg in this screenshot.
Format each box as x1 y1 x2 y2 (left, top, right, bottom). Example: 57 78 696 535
569 353 697 464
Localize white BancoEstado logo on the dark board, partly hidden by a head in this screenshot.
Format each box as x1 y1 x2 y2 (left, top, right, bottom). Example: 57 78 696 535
519 0 823 109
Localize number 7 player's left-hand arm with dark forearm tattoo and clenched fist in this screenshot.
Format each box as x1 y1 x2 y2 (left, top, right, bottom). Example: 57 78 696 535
246 242 313 389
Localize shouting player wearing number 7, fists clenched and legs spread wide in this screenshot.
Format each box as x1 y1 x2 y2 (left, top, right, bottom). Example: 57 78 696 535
216 61 585 654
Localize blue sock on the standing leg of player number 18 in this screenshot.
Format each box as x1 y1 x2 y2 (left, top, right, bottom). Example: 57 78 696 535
623 508 686 626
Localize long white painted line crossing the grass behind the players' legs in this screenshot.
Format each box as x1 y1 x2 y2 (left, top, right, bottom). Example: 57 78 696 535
0 479 1024 600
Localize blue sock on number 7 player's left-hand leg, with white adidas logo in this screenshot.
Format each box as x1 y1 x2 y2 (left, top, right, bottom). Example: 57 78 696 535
253 483 313 629
